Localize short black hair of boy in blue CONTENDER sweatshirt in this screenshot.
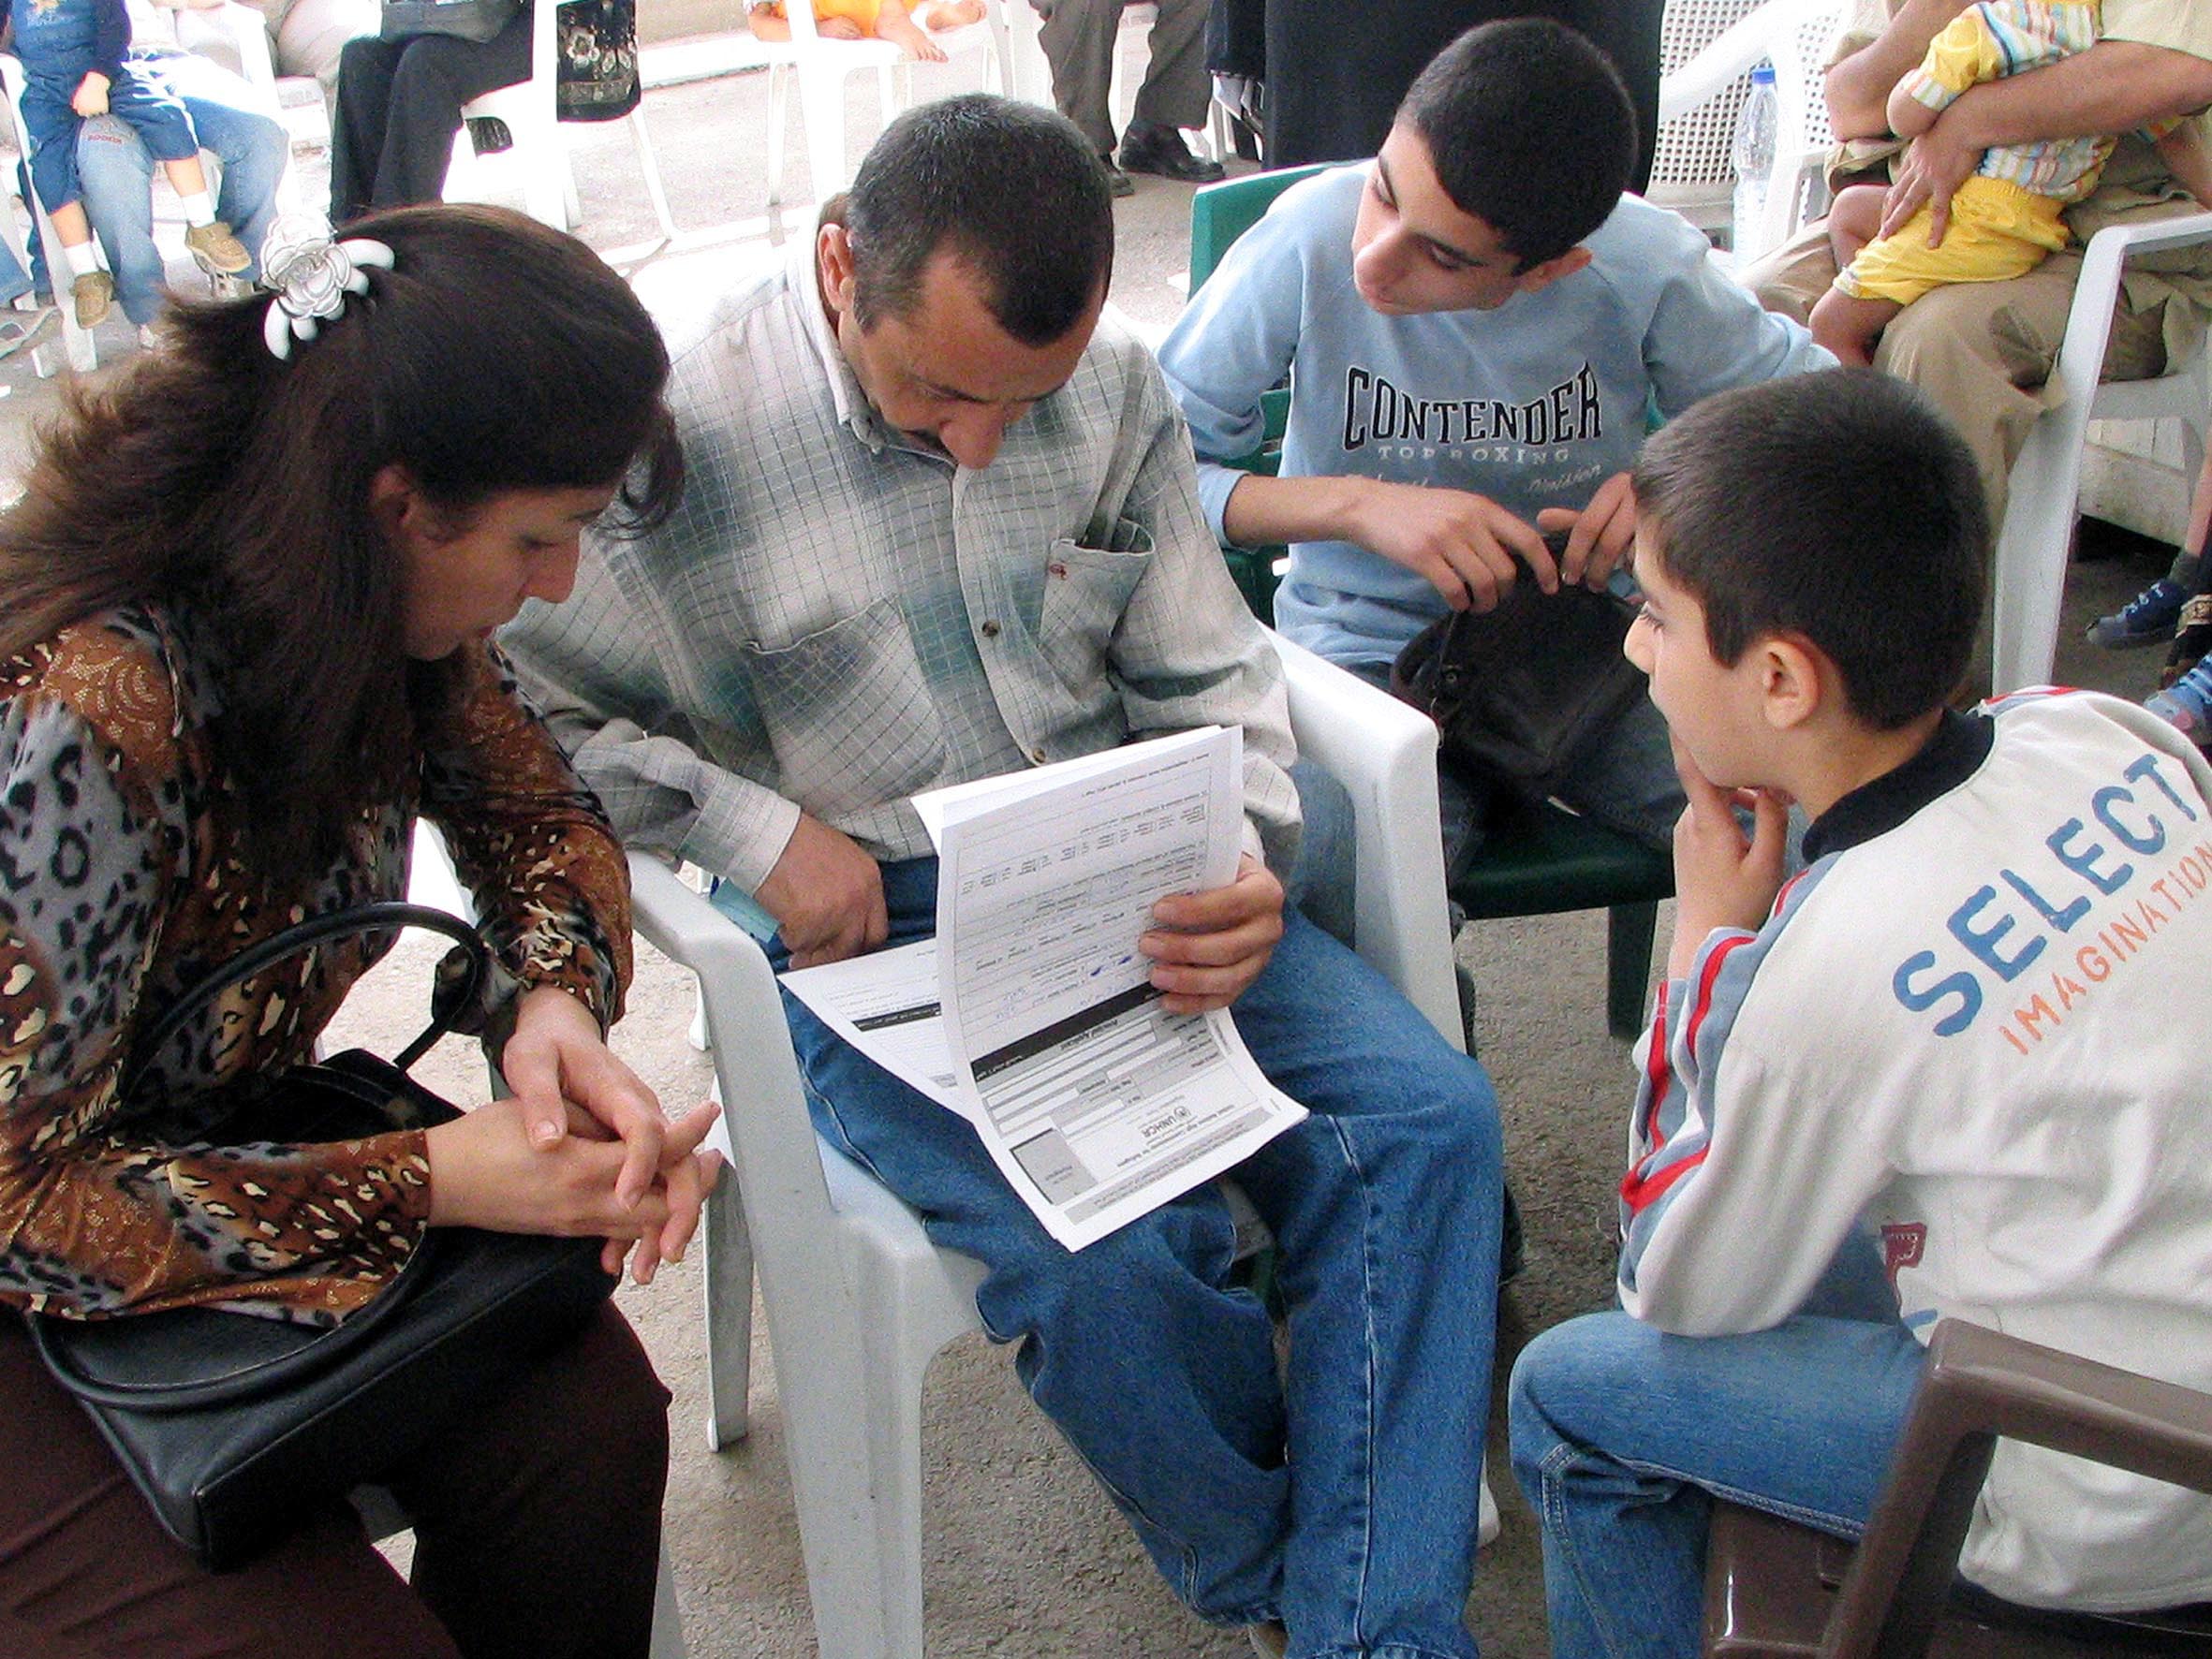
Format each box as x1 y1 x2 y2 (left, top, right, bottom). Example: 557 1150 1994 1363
1398 18 1637 270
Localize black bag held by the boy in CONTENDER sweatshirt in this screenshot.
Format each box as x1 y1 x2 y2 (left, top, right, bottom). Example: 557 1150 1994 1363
1392 537 1645 799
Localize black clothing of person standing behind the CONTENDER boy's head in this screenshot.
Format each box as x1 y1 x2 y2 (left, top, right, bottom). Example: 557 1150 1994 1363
1267 0 1666 190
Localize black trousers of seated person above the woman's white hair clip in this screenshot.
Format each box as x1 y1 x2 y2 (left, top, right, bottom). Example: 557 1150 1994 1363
330 0 535 226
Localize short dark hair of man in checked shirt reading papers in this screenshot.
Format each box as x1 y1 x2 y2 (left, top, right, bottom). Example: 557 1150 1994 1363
843 93 1113 345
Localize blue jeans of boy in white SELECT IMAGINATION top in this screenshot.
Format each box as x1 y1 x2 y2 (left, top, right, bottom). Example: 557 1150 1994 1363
1509 1241 1924 1659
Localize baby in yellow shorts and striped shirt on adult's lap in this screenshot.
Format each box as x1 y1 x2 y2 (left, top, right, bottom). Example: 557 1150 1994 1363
1811 0 2212 365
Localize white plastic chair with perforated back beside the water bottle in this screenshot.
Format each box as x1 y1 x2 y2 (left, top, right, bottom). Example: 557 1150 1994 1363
1652 0 1851 263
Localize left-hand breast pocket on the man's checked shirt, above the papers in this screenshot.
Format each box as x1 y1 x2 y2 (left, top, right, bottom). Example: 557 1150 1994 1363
745 599 945 816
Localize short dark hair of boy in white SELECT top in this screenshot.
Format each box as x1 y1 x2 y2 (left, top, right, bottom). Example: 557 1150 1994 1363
1635 370 1988 730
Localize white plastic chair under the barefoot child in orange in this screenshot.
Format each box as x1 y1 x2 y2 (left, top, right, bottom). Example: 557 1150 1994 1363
761 0 1025 201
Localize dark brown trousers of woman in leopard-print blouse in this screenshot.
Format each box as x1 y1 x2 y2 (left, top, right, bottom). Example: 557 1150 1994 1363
0 1307 668 1659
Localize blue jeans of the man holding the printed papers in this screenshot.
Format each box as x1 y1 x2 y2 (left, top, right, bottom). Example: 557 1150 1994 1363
743 859 1502 1659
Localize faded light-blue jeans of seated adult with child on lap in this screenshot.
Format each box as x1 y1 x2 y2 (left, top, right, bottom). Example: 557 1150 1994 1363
78 53 292 323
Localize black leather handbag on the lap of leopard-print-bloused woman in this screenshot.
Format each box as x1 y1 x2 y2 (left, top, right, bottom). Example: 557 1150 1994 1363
29 904 615 1570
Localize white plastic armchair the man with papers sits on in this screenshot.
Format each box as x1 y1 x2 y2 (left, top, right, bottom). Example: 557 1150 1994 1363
630 639 1497 1659
